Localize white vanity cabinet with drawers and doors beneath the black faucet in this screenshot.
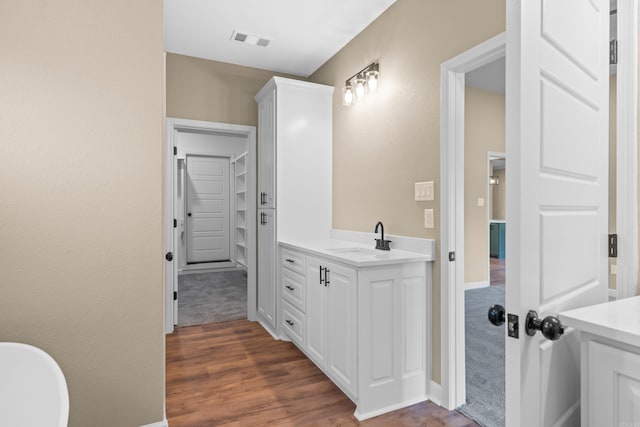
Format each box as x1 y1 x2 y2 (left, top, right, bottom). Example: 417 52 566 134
279 242 431 420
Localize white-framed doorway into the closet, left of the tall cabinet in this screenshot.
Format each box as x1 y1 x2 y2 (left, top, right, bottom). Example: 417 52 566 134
165 118 257 333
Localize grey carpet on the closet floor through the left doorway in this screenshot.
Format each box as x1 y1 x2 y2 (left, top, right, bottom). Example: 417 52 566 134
178 270 247 326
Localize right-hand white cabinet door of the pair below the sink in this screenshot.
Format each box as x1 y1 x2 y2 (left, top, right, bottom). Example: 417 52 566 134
325 263 357 397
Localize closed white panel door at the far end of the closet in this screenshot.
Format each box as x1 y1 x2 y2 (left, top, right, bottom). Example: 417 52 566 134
186 155 230 264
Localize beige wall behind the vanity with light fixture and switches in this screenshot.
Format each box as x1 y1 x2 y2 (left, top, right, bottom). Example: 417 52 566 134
310 0 505 383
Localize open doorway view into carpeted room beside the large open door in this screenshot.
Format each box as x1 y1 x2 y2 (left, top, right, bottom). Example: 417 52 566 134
458 58 507 427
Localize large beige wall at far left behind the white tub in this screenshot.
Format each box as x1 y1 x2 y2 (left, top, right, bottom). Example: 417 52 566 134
0 0 164 427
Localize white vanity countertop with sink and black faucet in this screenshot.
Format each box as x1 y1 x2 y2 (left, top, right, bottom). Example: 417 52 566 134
279 238 433 267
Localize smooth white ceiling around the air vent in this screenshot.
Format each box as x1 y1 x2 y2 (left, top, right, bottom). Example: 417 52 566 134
164 0 396 77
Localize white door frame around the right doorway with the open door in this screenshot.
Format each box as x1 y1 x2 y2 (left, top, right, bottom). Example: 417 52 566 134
440 0 638 410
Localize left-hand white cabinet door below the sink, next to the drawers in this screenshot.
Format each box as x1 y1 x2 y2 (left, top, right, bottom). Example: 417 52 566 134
305 257 327 366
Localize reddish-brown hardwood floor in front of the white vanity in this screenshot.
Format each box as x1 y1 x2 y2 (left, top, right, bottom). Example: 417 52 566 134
166 320 477 427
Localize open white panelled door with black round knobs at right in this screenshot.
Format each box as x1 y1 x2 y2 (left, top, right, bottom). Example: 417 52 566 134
506 0 609 427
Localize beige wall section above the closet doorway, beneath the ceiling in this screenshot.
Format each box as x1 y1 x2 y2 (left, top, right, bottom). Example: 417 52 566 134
167 53 306 126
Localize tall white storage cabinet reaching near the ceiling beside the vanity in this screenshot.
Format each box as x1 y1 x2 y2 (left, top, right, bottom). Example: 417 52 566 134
256 77 333 334
